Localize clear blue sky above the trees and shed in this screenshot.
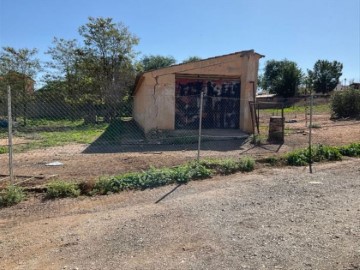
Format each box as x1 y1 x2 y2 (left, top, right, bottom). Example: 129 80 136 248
0 0 360 82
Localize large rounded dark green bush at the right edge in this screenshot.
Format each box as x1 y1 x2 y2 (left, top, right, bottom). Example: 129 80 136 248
330 89 360 118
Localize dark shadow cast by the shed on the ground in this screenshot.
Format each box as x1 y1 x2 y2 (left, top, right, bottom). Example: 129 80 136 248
83 119 253 154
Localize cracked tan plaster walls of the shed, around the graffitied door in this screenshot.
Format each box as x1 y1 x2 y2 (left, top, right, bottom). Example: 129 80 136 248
133 53 261 133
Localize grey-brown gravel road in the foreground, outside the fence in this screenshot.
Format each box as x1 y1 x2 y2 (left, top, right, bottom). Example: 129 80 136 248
0 159 360 270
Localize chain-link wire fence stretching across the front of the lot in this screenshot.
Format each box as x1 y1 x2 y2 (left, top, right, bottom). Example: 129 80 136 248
0 88 360 188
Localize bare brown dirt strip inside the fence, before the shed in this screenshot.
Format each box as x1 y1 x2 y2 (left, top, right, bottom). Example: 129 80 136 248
0 115 360 188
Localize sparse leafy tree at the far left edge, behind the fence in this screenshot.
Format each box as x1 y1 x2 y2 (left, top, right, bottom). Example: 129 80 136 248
0 47 41 125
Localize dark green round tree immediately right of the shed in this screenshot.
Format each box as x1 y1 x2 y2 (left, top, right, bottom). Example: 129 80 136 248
260 59 302 97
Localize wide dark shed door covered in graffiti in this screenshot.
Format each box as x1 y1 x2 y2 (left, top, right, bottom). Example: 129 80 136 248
175 78 240 129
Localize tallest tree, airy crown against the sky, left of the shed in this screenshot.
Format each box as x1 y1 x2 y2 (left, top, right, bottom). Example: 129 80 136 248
79 17 139 120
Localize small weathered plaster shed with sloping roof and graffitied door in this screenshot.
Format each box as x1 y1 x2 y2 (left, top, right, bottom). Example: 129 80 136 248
133 50 263 133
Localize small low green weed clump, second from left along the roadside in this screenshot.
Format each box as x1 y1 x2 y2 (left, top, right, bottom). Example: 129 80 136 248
46 180 80 199
